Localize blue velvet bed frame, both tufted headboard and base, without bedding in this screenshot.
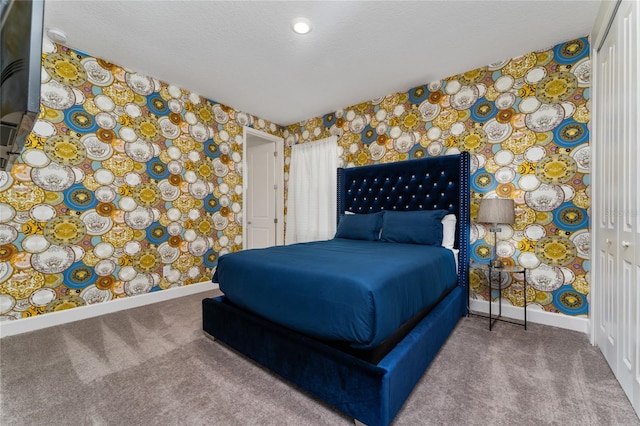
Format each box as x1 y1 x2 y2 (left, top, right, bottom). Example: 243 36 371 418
202 152 470 426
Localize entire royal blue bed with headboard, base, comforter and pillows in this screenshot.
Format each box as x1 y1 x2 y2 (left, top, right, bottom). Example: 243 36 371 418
202 153 470 425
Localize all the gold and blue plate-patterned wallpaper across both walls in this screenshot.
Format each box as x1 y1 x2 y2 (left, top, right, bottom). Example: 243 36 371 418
0 38 590 320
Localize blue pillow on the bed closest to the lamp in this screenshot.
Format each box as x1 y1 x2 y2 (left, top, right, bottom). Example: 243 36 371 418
381 210 449 246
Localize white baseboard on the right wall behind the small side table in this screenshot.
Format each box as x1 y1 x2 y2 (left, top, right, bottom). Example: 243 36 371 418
469 300 589 334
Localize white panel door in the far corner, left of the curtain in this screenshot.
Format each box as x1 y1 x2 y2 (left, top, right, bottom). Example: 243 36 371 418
246 141 278 248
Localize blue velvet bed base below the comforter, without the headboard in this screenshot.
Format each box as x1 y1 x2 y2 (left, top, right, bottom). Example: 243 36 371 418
202 286 466 426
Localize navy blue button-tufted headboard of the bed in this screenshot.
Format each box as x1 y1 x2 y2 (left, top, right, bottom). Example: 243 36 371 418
336 152 471 292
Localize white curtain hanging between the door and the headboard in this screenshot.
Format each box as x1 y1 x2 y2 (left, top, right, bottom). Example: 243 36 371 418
285 136 338 244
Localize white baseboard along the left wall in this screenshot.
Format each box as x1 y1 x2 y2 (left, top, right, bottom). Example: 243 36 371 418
0 281 218 338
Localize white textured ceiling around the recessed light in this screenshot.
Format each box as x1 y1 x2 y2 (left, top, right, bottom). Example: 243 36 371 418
45 0 601 125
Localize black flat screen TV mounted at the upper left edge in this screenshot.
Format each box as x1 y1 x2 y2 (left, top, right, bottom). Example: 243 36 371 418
0 0 44 170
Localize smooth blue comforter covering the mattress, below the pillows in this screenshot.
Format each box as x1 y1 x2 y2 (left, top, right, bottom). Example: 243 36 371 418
213 238 457 349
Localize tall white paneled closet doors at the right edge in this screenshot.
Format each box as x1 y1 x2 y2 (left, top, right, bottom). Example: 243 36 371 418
595 1 640 413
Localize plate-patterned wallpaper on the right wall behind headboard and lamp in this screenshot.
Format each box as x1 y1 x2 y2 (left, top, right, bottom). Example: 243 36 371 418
284 37 591 315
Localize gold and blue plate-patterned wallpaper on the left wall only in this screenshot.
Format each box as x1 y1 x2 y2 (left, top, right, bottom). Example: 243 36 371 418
0 39 282 320
